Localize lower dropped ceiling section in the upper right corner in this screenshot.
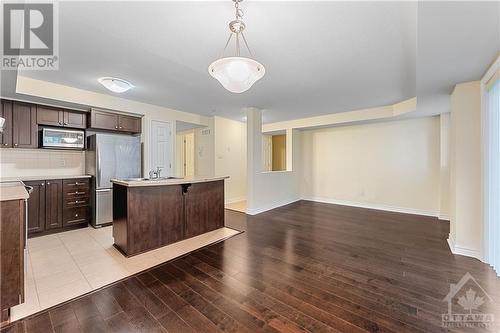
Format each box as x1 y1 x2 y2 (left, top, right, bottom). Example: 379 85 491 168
417 1 500 114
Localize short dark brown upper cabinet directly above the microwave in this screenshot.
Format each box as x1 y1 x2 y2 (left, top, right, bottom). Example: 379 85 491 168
36 105 87 128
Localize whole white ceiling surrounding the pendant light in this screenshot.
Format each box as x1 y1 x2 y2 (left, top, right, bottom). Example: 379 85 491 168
2 1 500 123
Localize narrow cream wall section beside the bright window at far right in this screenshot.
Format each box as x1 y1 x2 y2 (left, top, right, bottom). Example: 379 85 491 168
449 81 483 259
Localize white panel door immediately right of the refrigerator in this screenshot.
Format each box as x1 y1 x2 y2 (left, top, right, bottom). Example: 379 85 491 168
150 120 173 177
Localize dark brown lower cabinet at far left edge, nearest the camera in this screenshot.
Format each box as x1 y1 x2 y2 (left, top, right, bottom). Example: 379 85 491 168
0 200 25 322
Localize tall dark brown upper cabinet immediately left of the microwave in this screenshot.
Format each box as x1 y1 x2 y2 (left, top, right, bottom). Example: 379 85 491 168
12 102 38 148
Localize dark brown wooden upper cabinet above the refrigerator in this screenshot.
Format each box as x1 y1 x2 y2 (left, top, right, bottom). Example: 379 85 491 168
89 110 141 133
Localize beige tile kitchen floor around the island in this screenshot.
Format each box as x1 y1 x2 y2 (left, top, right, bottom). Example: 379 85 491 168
11 227 238 320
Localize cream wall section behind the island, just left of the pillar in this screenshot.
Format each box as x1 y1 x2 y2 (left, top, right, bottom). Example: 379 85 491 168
215 117 247 203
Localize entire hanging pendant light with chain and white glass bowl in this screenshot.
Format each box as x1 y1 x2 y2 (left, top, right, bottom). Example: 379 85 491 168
208 0 266 93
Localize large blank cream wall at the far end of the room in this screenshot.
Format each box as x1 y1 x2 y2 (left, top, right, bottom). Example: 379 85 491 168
301 117 440 216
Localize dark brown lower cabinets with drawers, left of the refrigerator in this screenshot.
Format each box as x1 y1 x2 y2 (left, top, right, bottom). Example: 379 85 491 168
24 178 90 237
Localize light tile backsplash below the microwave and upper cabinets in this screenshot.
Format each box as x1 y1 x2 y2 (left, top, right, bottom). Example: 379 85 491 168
0 149 85 177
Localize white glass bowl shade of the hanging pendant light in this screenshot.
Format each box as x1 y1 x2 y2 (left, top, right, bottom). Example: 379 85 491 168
208 57 266 93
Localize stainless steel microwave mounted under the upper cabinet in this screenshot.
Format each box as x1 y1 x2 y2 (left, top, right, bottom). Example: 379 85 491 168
40 127 85 150
